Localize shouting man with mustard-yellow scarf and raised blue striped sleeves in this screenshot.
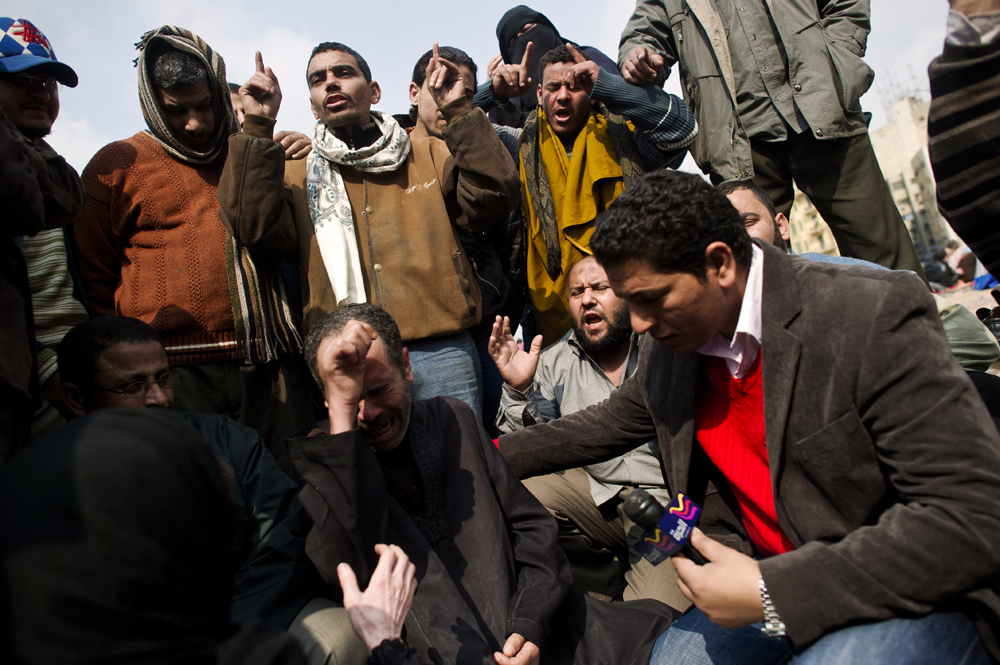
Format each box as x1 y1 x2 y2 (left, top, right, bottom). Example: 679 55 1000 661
476 44 698 346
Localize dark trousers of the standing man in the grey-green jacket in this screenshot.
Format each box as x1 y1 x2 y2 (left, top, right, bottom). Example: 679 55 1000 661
751 132 927 282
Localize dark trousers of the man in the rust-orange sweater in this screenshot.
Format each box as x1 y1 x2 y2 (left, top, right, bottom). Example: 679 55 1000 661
173 356 317 478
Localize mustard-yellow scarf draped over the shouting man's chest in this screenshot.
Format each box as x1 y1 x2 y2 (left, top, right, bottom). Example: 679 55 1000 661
520 107 634 346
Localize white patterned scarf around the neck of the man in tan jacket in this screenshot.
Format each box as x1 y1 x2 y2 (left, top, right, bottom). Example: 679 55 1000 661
306 112 410 307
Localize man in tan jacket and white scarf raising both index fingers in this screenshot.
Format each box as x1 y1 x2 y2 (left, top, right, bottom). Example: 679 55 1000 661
219 42 520 415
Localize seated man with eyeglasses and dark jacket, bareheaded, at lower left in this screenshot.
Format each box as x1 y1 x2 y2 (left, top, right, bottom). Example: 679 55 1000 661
50 316 366 662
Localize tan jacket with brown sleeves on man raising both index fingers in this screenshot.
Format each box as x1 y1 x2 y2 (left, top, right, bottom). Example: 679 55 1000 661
219 99 520 341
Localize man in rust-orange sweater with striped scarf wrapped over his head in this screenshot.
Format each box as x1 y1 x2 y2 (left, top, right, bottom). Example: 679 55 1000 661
73 26 313 472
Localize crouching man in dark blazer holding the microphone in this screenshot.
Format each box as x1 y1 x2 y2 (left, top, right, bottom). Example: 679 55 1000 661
499 172 1000 663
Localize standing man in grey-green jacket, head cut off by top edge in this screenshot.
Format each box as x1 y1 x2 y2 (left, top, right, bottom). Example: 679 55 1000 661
618 0 923 276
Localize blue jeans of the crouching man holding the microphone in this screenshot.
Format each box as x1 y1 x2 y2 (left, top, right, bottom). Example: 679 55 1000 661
649 608 990 665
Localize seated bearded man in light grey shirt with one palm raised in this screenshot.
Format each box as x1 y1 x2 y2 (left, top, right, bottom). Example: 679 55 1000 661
489 256 690 610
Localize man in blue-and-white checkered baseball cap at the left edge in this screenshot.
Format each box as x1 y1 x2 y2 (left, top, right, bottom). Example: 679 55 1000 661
0 17 86 464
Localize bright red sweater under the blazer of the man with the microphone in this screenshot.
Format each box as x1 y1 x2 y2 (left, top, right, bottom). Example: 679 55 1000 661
695 353 795 556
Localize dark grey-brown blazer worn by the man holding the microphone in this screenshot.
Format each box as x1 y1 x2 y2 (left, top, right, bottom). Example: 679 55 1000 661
500 245 1000 657
